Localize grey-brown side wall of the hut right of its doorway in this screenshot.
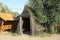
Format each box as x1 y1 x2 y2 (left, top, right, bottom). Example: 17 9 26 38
30 16 45 34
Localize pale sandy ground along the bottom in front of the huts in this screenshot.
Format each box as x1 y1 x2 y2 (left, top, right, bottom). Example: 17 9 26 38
0 34 60 40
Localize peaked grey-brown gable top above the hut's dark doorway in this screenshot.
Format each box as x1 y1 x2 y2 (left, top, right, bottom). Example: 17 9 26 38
17 5 35 19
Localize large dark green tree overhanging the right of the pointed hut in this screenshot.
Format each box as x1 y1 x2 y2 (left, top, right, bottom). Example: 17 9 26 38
28 0 60 33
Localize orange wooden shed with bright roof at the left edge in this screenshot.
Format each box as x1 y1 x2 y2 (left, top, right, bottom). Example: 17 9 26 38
0 13 17 32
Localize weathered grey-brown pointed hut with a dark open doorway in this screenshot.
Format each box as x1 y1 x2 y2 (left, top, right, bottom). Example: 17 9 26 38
17 6 44 35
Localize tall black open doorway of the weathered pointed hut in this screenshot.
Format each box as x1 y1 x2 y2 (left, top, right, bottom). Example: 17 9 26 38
22 18 31 34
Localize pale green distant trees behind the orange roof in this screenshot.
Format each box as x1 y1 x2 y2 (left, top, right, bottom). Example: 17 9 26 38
0 2 18 16
